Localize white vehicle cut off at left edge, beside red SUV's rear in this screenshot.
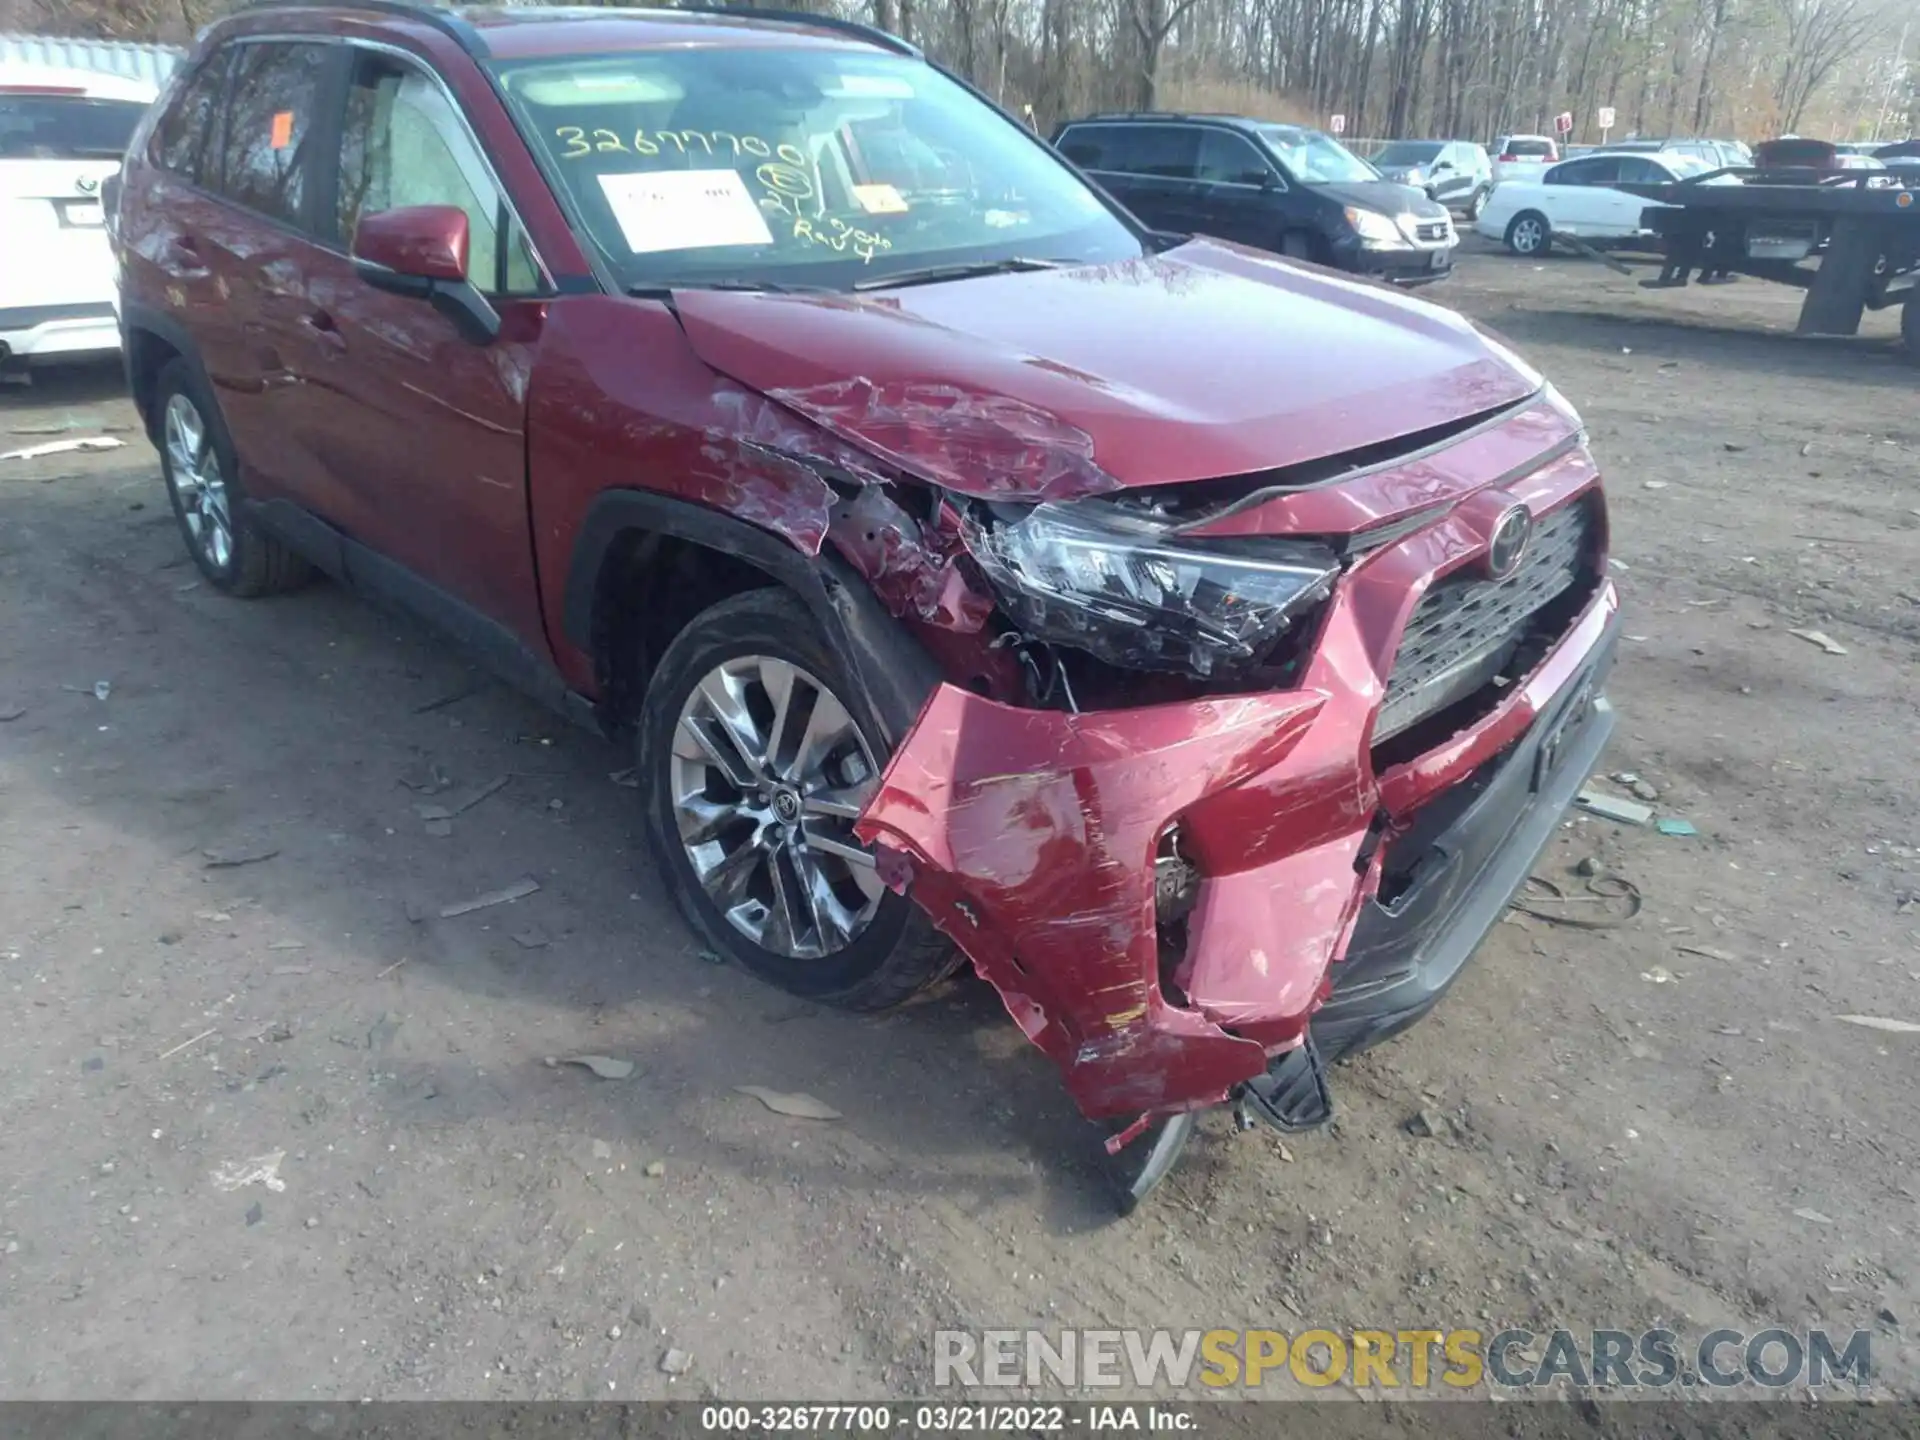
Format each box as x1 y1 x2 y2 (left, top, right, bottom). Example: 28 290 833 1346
0 65 157 365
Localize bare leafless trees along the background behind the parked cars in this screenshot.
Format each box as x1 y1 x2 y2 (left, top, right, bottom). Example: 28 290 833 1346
18 0 1920 142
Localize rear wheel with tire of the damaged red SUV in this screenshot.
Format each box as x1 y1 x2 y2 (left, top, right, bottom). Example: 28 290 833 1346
154 359 313 599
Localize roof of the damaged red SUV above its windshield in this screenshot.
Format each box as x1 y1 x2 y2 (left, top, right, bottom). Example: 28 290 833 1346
209 0 920 60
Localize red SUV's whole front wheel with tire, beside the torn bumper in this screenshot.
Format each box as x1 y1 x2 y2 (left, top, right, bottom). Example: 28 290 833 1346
636 588 952 1010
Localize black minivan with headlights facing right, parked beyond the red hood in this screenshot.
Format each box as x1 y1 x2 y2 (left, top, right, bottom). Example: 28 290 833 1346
1054 115 1455 284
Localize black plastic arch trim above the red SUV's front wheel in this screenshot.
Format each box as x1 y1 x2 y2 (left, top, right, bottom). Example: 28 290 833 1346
561 490 943 751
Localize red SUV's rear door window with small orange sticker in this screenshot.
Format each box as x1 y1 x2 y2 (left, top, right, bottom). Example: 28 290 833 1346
204 40 332 225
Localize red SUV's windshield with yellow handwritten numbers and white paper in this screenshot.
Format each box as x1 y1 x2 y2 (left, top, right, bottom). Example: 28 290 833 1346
499 46 1144 290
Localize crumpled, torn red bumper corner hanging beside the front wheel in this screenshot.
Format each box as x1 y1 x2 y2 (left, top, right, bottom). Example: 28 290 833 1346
856 685 1336 1117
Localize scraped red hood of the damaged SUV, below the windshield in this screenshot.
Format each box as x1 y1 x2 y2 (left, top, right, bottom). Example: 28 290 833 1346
674 240 1540 499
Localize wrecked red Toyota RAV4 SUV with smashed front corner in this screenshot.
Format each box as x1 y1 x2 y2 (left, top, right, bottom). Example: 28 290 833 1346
111 0 1617 1206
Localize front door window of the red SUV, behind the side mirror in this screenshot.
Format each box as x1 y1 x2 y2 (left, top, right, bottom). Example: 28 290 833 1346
334 54 540 294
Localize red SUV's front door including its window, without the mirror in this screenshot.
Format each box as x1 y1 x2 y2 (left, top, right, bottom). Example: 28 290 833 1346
300 46 547 651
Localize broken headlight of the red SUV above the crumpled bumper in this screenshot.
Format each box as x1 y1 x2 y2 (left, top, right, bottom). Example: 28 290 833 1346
968 501 1340 676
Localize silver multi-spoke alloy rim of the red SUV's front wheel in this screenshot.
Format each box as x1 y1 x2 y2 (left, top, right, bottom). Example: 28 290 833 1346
670 655 885 960
